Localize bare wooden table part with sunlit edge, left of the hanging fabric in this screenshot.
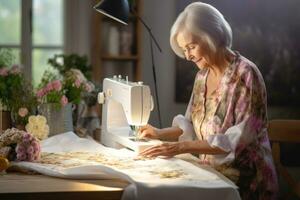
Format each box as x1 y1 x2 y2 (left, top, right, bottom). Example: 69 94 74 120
0 173 129 200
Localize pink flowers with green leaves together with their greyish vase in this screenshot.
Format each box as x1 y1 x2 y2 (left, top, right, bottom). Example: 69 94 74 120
37 69 94 135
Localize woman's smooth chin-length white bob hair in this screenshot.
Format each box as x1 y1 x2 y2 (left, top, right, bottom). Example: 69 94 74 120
170 2 232 64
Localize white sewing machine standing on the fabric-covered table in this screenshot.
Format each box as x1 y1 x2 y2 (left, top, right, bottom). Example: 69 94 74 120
98 75 160 152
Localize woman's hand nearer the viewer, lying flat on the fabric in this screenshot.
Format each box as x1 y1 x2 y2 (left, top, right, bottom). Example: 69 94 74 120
139 142 184 158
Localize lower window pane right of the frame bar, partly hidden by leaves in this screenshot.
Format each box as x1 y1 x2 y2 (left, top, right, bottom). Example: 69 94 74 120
32 49 62 87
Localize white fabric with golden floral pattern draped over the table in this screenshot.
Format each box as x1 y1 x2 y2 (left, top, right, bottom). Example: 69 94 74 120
12 132 240 200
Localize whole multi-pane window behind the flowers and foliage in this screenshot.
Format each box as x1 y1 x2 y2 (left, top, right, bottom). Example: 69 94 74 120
0 0 64 86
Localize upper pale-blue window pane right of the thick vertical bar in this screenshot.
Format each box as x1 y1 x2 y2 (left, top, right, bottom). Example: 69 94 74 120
33 0 63 45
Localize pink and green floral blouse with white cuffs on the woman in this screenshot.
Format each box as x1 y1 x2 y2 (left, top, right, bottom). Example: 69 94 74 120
173 53 277 199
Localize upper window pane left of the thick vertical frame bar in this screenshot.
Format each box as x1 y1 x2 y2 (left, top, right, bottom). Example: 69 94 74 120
0 0 21 45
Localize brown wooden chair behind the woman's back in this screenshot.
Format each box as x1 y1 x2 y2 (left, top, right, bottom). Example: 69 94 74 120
268 120 300 198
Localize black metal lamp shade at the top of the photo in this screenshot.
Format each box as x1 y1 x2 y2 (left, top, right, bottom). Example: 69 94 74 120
94 0 129 25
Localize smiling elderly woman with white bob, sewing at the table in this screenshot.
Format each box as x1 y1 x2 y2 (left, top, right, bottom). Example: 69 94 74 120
140 2 277 199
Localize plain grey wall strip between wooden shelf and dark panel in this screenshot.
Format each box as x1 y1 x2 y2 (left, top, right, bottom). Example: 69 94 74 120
142 0 186 127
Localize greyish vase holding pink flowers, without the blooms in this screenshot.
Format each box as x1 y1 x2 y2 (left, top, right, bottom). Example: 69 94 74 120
38 103 73 136
